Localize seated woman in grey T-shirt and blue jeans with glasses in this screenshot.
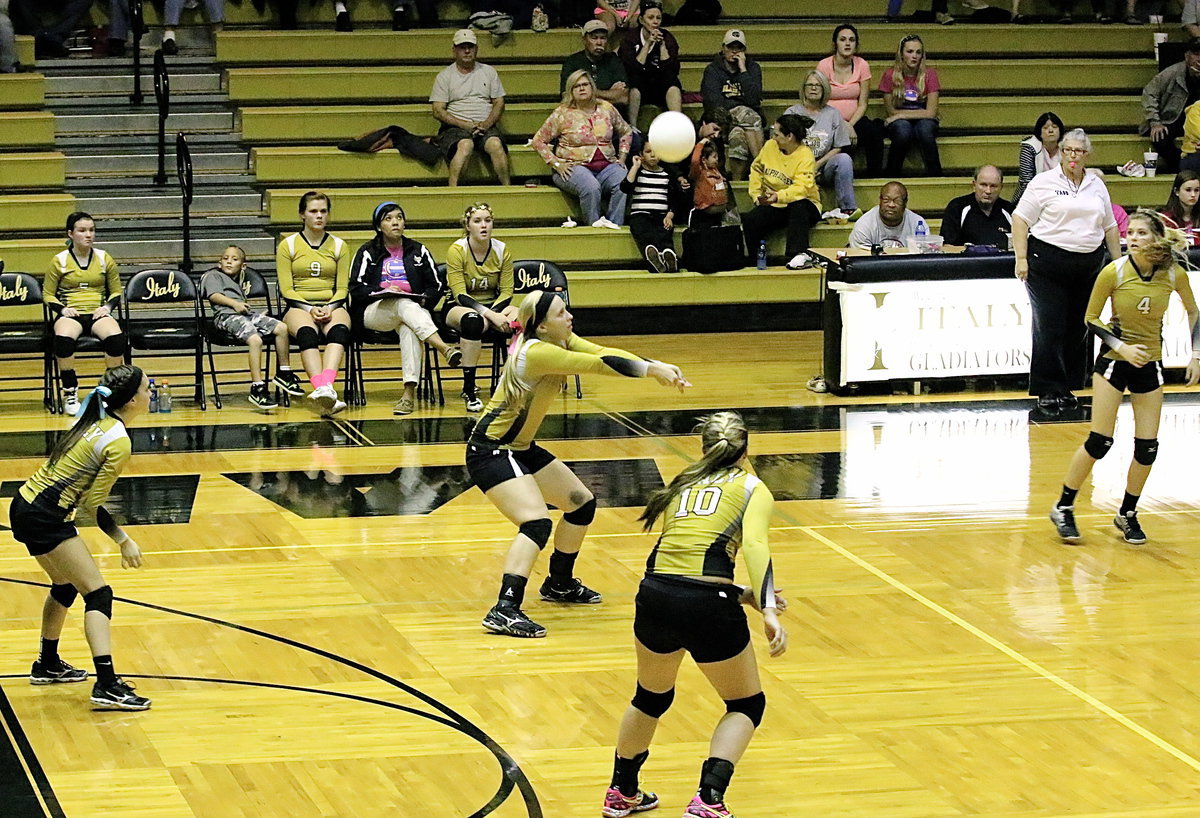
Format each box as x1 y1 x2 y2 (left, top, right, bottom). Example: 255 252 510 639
784 71 863 222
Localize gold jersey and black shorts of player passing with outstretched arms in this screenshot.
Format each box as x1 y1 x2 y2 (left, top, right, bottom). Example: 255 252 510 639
467 335 648 492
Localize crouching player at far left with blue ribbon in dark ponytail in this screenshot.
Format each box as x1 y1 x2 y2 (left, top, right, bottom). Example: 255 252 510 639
8 363 150 710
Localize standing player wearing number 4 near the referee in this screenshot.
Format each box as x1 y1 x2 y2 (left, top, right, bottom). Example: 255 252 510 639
1050 210 1200 545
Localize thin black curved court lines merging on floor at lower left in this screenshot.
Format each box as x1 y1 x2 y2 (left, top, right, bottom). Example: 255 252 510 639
0 577 545 818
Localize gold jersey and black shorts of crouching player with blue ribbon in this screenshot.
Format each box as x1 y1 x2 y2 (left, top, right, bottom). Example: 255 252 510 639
8 415 132 557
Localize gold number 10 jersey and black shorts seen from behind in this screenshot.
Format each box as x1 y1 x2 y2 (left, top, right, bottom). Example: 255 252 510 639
634 467 775 663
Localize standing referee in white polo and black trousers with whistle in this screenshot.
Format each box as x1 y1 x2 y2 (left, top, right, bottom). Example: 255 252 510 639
1013 128 1121 414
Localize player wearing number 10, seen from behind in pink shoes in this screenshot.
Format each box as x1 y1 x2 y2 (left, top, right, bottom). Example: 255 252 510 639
601 411 787 818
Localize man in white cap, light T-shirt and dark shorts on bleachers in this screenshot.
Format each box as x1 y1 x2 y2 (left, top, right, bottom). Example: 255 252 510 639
430 29 512 187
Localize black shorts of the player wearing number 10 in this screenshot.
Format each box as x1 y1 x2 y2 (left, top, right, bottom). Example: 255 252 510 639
634 573 750 664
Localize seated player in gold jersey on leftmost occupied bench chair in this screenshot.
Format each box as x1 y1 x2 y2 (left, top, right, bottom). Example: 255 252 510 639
42 211 126 417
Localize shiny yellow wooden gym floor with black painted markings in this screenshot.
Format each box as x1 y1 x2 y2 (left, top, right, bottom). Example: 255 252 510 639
0 333 1200 818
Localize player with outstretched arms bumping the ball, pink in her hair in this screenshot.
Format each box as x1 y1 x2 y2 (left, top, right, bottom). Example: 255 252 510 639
467 290 690 637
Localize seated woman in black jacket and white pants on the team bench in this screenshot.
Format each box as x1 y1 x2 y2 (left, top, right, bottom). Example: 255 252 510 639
350 202 462 415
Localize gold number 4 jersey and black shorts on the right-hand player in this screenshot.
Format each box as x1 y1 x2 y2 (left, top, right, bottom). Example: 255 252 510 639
1085 255 1196 393
